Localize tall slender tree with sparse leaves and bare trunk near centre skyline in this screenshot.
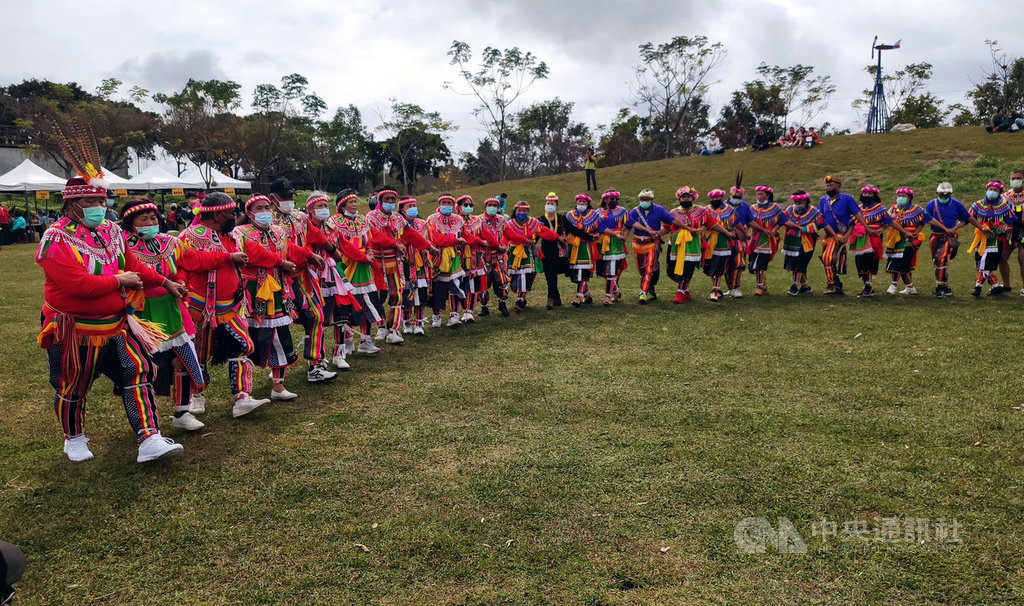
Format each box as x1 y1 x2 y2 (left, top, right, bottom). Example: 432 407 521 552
444 40 549 181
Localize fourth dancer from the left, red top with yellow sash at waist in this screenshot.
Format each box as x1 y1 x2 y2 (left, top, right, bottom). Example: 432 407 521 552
231 194 313 400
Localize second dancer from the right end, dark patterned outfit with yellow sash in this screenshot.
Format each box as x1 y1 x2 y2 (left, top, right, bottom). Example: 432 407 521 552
967 181 1017 297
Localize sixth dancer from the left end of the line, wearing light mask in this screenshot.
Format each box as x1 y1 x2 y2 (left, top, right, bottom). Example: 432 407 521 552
306 191 360 371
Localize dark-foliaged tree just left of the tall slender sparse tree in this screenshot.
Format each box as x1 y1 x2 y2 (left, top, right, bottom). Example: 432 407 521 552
377 99 456 193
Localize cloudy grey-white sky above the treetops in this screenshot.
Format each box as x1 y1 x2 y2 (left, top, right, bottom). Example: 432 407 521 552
6 0 1024 174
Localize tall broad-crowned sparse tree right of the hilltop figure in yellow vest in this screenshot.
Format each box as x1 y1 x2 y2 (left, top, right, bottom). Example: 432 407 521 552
633 36 725 158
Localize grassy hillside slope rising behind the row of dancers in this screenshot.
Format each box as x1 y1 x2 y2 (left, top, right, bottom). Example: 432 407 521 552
428 127 1024 204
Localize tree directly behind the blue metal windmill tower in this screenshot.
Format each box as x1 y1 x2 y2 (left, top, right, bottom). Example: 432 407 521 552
852 61 948 128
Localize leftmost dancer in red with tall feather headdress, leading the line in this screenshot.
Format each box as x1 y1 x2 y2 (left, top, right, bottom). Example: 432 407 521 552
36 133 186 463
